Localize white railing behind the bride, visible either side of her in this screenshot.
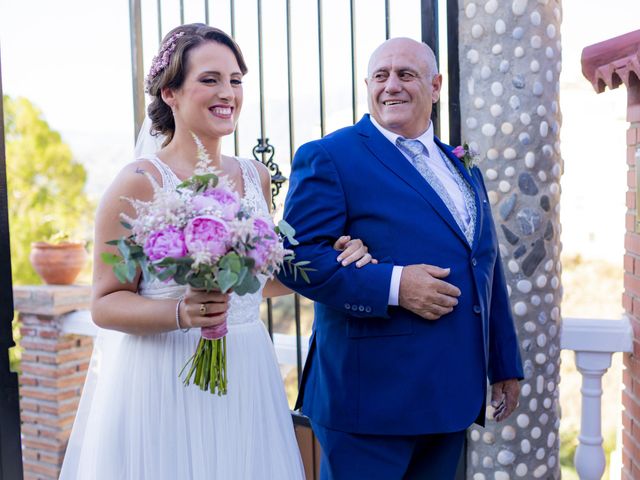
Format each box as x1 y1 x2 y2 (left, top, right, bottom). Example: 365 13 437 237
60 310 309 371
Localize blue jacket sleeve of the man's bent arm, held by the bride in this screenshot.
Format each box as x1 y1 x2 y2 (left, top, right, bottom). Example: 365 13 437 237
279 142 393 317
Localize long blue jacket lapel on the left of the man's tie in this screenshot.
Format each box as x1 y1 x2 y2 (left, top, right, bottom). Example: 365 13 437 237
355 115 470 246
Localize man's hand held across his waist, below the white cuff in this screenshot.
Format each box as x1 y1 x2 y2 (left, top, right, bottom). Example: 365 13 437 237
398 265 460 320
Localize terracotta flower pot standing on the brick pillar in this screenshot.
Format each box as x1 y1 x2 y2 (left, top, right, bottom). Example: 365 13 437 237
29 242 87 285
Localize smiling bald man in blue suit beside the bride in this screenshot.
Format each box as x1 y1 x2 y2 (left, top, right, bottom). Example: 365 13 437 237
281 38 523 480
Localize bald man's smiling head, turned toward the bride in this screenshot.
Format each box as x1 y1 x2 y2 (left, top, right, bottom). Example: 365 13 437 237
365 39 442 138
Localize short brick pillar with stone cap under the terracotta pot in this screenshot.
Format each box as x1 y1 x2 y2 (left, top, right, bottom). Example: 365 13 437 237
14 286 93 480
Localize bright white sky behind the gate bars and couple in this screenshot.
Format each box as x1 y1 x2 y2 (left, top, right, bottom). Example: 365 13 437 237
0 0 640 263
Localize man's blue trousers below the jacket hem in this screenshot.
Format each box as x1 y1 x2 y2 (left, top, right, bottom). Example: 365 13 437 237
312 422 465 480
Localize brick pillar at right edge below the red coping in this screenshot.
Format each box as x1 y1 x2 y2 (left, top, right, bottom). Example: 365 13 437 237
622 85 640 480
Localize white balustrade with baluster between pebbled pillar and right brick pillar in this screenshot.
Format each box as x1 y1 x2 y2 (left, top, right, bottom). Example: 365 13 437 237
560 317 633 480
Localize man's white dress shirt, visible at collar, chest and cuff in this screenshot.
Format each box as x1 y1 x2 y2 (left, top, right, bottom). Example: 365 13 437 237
369 116 471 306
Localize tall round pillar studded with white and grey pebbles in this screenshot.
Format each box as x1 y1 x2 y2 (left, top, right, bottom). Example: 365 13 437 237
459 0 562 480
